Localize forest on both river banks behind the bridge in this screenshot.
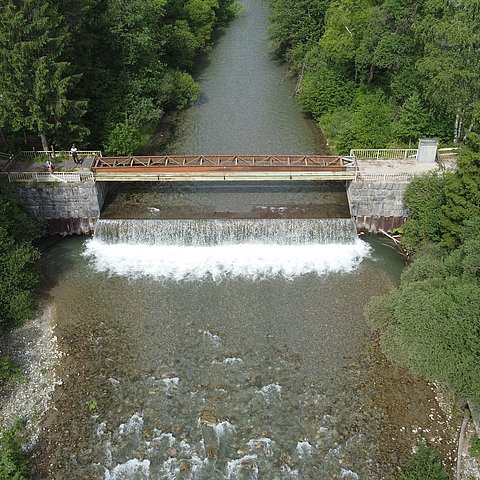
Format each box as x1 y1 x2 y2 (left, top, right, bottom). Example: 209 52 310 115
0 0 480 154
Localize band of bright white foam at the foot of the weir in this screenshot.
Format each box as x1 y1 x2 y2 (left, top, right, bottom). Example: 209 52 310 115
83 238 370 281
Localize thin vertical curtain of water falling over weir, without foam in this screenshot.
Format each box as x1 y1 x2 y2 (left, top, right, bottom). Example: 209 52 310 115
95 218 357 247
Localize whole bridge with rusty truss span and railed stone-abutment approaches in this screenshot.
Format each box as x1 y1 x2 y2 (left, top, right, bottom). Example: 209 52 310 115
0 142 457 183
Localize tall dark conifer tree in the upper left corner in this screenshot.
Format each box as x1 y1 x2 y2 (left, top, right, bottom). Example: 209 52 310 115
0 0 86 150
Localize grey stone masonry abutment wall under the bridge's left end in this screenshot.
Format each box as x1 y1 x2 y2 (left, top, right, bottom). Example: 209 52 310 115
15 182 107 235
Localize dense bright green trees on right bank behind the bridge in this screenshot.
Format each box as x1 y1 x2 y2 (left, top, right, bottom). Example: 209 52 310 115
271 0 480 153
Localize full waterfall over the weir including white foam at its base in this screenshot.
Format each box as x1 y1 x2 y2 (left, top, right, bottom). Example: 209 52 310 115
84 218 370 281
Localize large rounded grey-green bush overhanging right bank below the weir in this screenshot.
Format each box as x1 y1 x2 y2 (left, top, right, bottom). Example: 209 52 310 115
366 235 480 402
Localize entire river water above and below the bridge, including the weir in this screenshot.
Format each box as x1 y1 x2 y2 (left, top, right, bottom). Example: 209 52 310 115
18 0 458 480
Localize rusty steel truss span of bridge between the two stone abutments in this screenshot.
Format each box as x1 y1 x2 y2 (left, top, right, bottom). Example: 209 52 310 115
92 155 356 181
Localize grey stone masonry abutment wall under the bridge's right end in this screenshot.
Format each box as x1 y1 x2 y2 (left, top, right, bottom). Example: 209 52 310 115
347 179 408 233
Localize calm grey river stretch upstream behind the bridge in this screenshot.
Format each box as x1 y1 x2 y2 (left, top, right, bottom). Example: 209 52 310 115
149 0 327 155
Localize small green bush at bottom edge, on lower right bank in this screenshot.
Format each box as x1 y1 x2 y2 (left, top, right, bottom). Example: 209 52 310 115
398 443 448 480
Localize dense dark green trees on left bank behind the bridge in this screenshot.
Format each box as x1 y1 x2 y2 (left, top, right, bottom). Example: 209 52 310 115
0 0 235 154
